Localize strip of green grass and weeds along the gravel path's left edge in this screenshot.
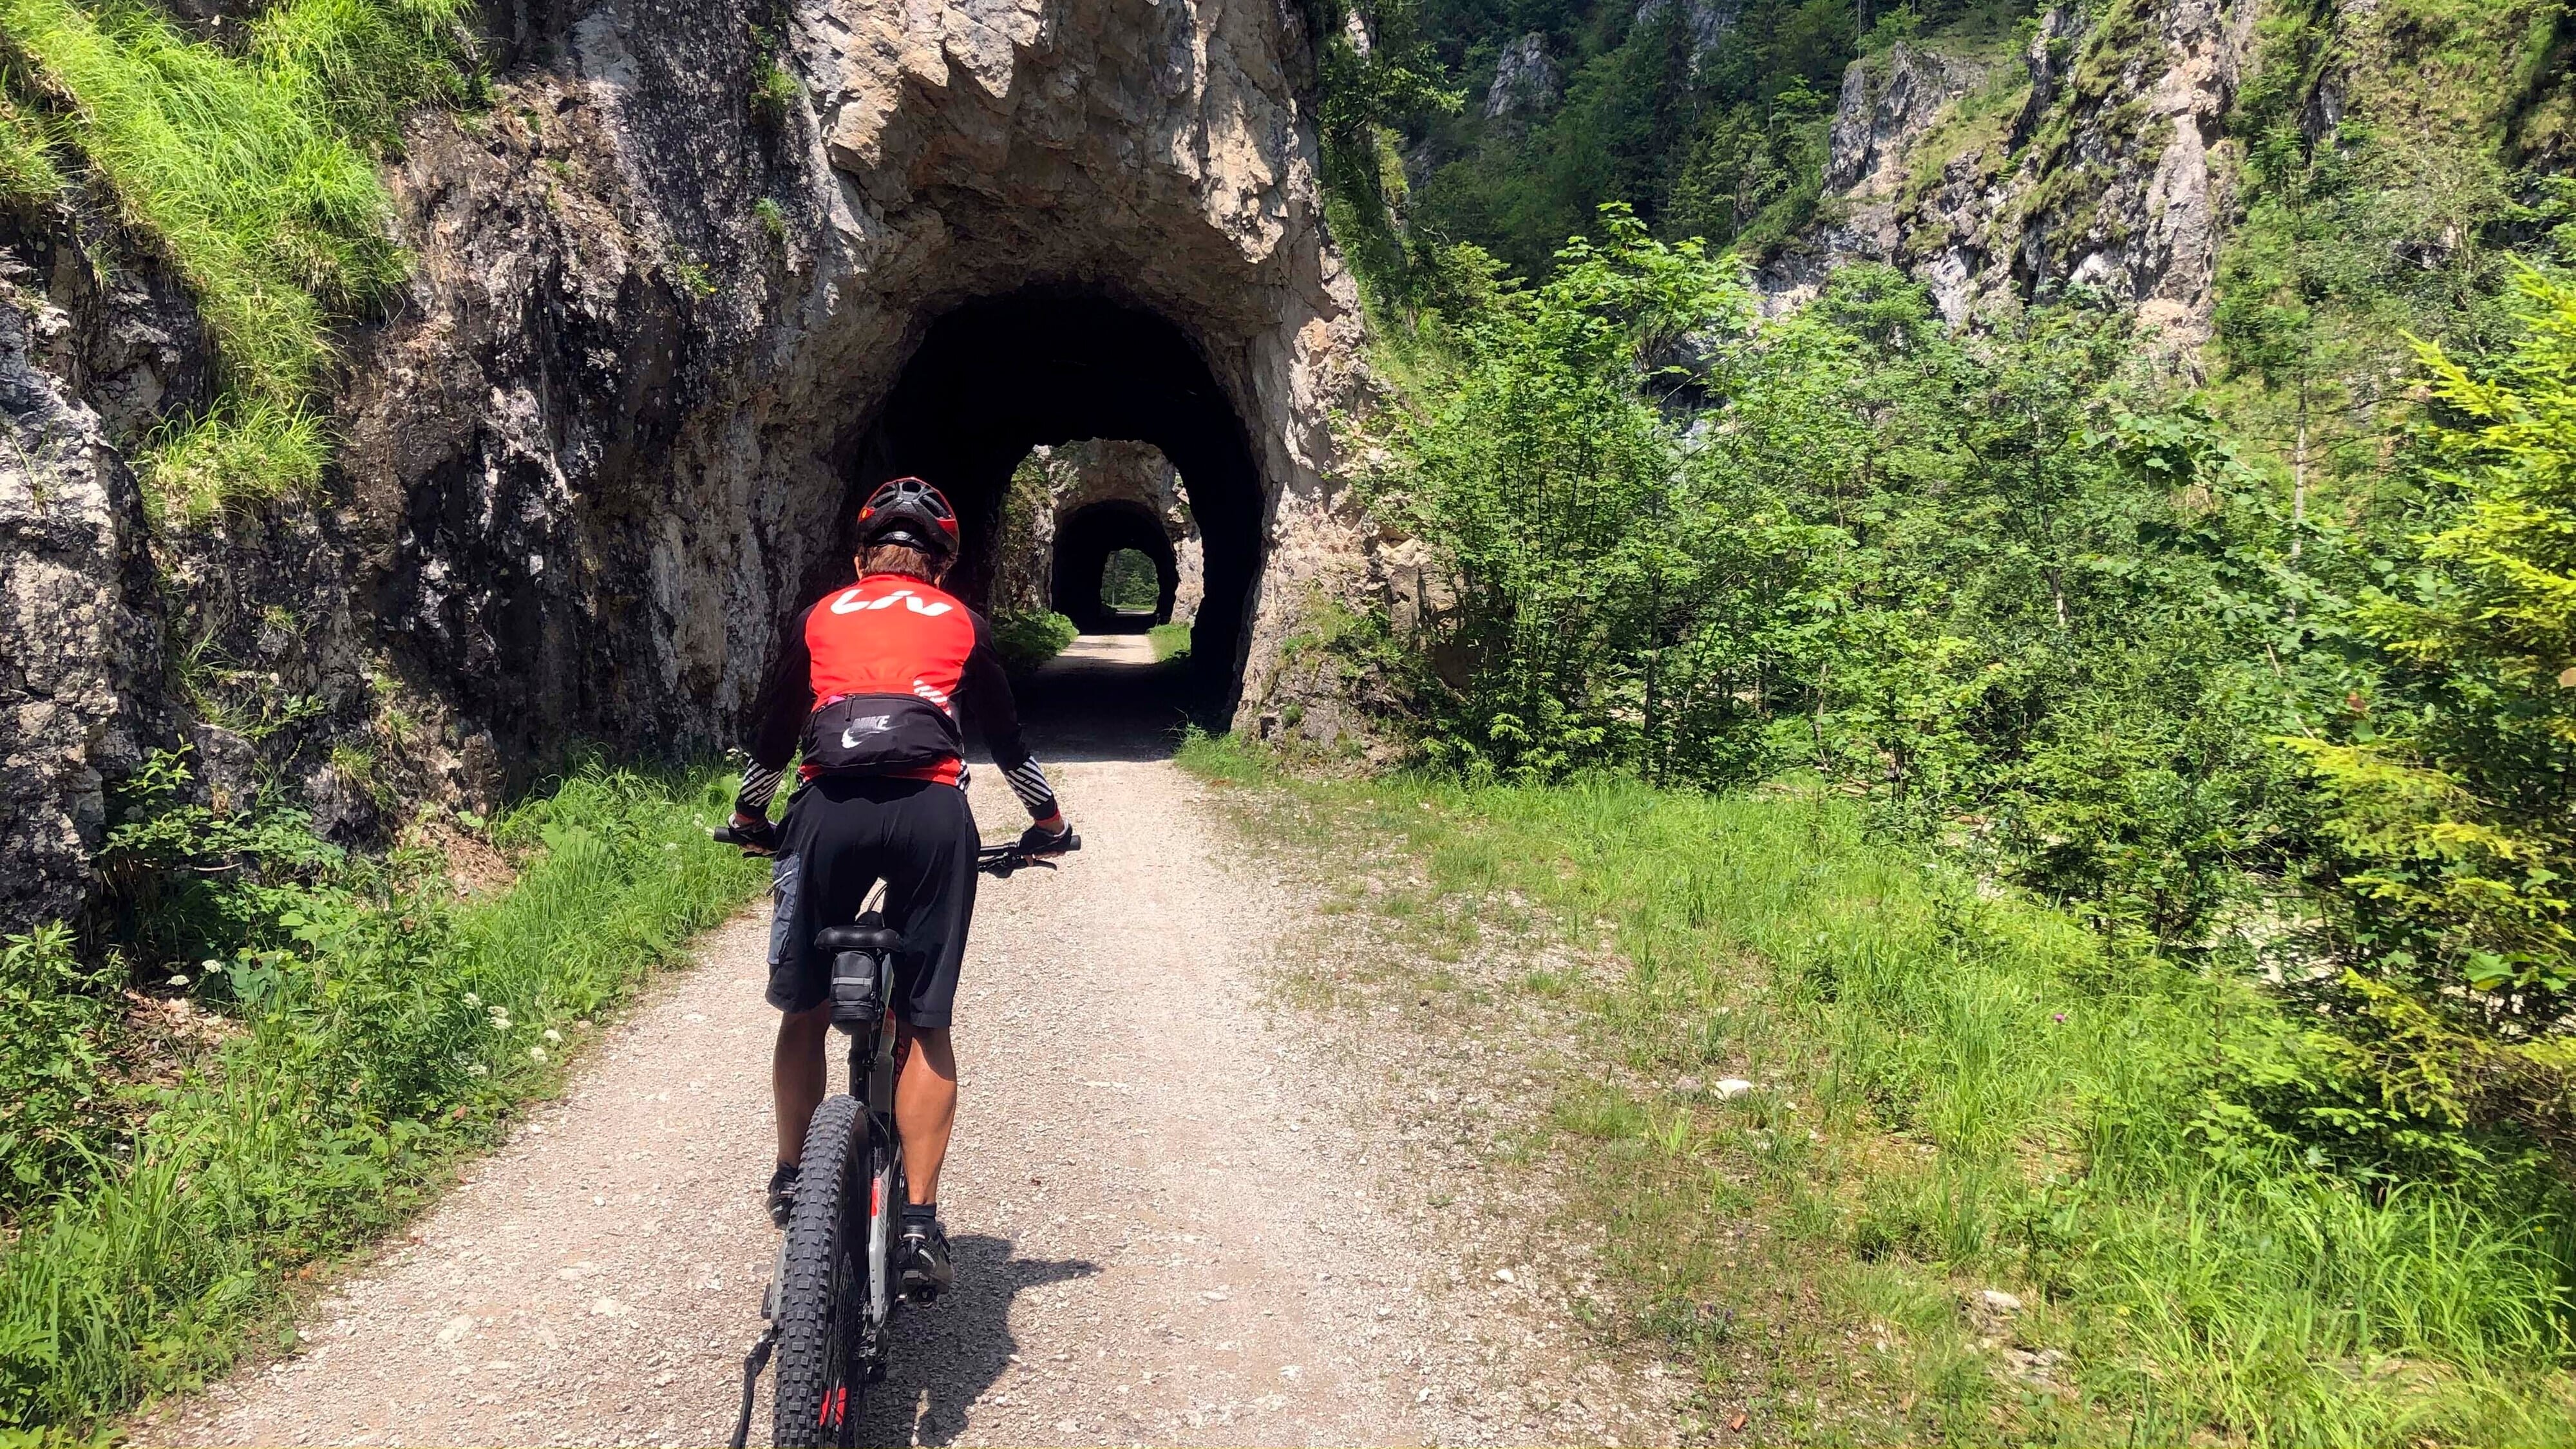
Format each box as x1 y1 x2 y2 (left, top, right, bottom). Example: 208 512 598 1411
0 771 765 1441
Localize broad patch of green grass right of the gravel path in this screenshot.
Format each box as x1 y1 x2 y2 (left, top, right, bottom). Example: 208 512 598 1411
1182 740 2576 1444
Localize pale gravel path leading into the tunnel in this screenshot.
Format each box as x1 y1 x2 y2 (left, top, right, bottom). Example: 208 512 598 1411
134 639 1669 1444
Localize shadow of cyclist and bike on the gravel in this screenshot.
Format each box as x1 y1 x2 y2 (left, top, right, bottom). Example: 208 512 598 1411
858 1233 1100 1444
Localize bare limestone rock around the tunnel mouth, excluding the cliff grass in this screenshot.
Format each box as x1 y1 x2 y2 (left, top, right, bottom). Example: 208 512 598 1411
0 0 1370 931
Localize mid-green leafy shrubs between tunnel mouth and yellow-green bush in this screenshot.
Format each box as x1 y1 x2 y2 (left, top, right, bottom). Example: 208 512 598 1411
1368 223 2303 946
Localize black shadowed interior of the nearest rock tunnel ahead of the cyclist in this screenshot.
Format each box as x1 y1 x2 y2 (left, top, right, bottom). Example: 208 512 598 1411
829 291 1262 712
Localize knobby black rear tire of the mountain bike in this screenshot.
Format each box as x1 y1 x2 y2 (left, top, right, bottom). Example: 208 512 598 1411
770 1096 871 1449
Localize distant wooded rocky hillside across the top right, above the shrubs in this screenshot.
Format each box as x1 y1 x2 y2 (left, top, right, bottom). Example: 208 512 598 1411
1406 0 2571 358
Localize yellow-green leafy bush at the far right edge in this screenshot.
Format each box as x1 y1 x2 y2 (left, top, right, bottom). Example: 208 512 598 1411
2287 273 2576 1163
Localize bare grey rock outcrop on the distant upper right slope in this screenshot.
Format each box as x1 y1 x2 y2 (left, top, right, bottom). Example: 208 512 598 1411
1757 0 2254 355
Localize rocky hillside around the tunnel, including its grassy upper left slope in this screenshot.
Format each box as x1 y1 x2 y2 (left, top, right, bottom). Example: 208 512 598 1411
0 0 1363 931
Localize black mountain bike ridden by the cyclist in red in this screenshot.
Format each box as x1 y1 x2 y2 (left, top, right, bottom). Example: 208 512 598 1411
716 830 1082 1449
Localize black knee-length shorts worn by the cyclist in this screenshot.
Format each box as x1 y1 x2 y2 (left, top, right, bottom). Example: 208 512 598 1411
768 779 981 1028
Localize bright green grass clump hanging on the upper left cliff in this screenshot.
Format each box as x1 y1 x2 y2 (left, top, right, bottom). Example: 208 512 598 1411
0 0 474 513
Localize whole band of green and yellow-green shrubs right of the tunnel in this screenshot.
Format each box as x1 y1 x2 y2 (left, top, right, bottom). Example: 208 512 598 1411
1363 211 2576 1176
